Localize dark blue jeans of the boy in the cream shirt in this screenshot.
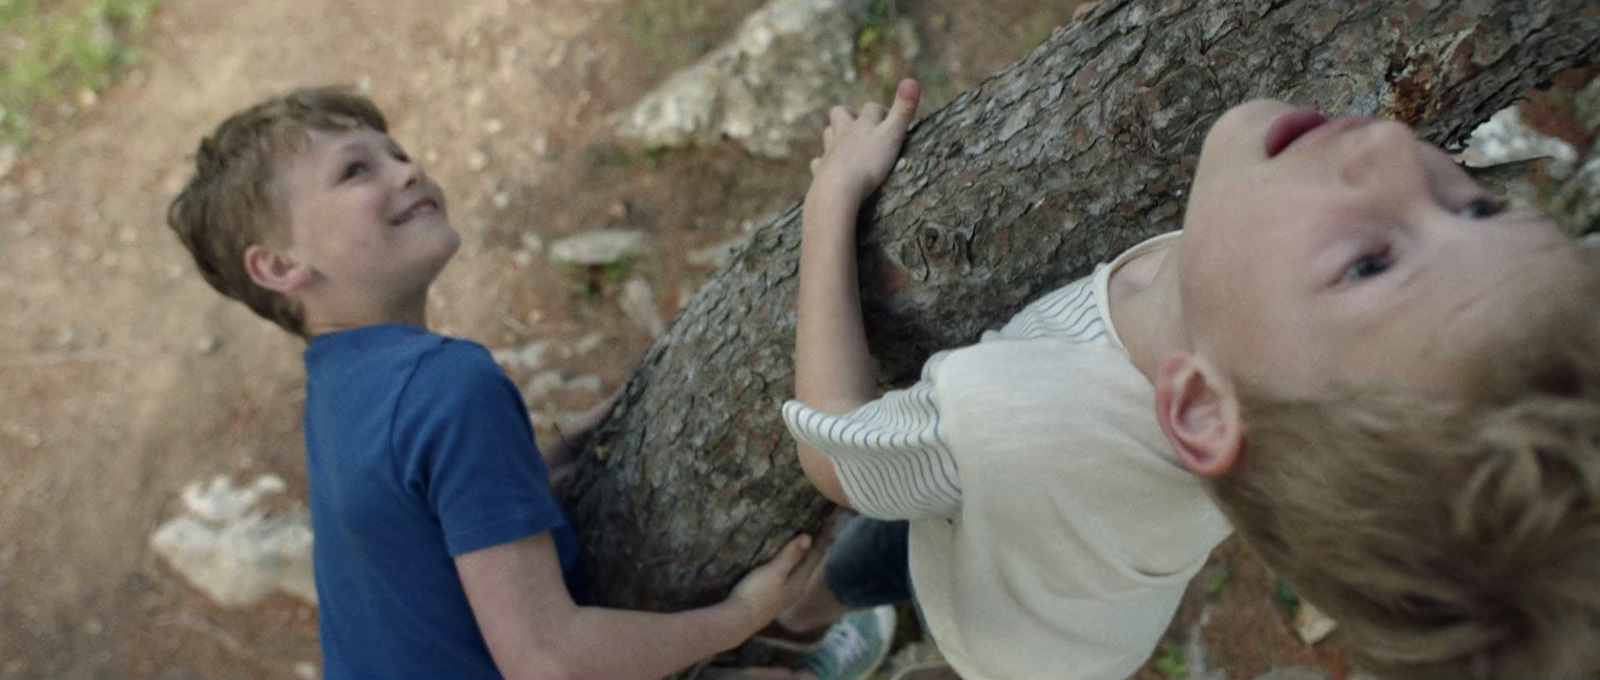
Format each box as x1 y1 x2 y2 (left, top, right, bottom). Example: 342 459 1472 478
822 515 912 610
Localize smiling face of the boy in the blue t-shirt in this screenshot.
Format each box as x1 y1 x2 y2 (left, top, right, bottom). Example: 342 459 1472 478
280 126 461 323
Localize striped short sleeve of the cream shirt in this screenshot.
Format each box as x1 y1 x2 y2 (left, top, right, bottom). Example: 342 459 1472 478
782 352 962 520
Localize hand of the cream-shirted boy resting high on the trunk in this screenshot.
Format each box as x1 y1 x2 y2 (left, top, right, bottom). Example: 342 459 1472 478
811 78 922 200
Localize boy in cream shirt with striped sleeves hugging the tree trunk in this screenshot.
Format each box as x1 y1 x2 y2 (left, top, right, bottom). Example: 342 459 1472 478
778 80 1600 680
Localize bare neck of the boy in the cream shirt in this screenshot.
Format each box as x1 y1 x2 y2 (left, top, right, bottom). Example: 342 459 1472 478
1110 242 1189 384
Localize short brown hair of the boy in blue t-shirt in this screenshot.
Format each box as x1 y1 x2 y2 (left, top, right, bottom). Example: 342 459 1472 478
166 88 389 336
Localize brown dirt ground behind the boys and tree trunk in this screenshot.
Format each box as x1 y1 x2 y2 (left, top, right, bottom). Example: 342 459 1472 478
0 0 1342 678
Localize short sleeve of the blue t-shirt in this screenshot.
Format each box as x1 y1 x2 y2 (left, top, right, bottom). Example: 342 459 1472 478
394 341 566 557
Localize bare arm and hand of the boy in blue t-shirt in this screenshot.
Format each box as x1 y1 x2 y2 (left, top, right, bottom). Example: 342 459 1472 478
456 531 814 680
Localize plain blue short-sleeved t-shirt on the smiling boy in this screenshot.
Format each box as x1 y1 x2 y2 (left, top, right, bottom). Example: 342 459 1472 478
306 323 582 680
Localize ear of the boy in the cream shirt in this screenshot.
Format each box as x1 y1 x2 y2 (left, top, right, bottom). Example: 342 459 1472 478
1155 352 1245 477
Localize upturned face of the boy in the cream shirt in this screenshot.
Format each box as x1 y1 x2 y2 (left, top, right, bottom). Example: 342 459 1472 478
1179 101 1586 395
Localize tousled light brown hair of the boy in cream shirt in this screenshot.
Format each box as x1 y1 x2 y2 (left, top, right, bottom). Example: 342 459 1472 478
1213 251 1600 680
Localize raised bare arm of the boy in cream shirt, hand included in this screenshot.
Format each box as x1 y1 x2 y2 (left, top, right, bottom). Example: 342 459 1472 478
795 80 922 507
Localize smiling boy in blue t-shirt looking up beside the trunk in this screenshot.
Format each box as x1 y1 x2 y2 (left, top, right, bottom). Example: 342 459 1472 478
168 88 876 678
